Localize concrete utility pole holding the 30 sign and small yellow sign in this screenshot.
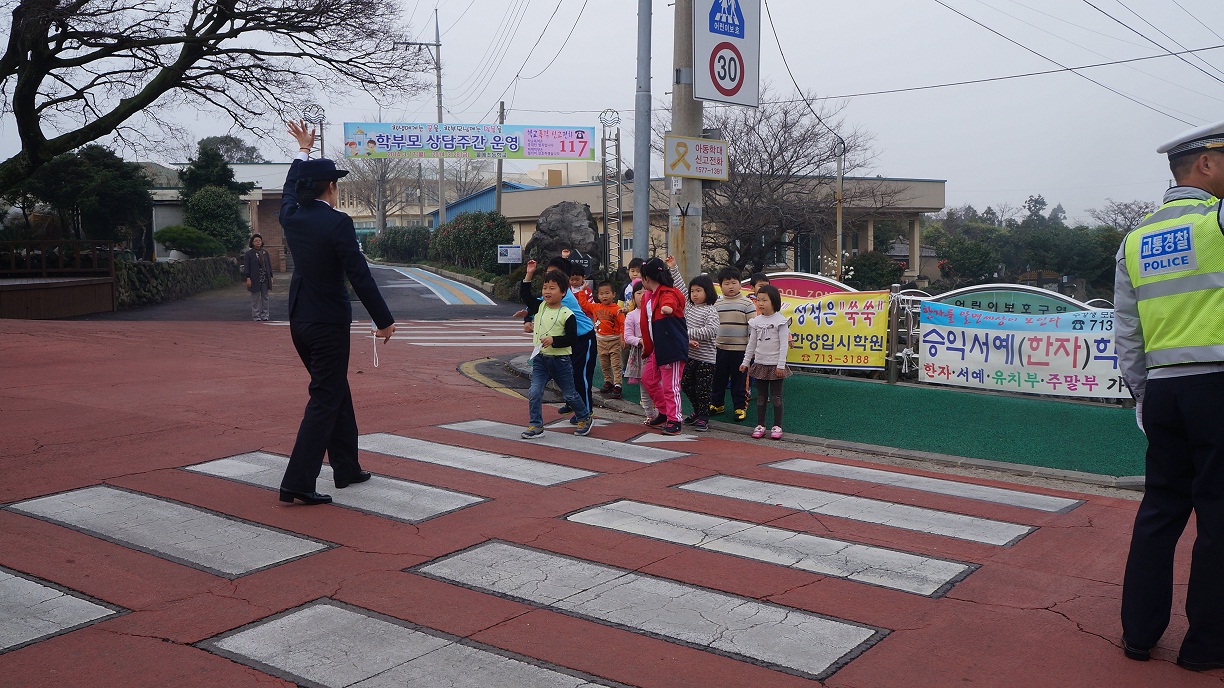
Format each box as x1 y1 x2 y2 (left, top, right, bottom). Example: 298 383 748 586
675 0 704 279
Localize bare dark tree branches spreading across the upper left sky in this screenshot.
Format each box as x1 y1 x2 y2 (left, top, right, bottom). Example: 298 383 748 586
0 0 431 191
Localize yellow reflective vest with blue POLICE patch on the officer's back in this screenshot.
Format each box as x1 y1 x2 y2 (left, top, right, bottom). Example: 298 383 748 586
1125 197 1224 368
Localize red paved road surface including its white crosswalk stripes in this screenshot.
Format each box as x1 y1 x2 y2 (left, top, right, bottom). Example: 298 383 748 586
0 266 1224 688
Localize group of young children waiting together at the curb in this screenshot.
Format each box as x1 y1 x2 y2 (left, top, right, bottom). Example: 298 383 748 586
519 255 791 439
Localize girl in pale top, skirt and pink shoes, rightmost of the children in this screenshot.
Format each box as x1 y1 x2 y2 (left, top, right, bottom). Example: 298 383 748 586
739 285 791 439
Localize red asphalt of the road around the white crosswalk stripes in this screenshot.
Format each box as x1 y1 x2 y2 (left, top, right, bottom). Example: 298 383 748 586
0 321 1224 688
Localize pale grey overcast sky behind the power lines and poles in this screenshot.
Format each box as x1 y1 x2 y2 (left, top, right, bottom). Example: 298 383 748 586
2 0 1224 219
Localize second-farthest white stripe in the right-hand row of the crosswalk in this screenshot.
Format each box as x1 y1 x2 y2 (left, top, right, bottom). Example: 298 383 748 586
677 475 1037 545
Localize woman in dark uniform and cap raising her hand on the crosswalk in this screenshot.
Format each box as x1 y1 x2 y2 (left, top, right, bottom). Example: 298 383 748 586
280 121 395 504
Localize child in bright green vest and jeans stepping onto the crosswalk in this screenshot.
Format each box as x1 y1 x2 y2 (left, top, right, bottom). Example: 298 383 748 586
521 271 592 439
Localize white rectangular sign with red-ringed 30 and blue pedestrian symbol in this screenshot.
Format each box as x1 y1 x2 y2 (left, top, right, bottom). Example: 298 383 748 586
693 0 761 108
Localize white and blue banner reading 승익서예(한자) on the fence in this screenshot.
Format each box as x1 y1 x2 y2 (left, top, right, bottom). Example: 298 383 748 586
918 302 1130 399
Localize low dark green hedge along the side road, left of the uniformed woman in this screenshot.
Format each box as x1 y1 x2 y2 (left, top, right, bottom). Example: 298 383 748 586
115 257 241 308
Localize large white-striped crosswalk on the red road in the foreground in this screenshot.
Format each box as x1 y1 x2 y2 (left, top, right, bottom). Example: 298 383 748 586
0 411 1081 687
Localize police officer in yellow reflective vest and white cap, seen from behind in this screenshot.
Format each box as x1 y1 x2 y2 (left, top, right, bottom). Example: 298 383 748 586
1114 122 1224 671
